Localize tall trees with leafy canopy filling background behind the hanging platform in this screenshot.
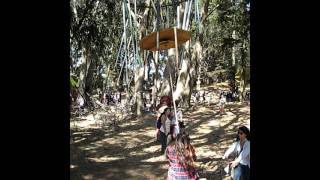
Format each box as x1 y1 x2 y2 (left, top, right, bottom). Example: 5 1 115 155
70 0 250 111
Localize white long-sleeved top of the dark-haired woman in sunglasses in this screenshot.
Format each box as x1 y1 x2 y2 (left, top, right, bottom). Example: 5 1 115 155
224 139 250 168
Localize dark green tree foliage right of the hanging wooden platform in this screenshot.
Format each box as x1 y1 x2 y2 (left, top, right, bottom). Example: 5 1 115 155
203 0 250 82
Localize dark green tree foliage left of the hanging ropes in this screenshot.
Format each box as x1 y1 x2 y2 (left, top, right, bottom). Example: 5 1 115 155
70 0 123 95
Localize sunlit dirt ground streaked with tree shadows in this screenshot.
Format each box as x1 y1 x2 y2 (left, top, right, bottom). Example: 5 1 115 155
70 84 250 180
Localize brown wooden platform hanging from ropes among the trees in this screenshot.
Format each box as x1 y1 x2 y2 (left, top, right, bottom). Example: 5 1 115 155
139 28 191 51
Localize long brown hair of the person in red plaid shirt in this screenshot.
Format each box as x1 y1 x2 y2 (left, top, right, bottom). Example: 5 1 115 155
175 133 194 176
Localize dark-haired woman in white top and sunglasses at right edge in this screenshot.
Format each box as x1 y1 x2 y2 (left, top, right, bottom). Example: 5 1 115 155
222 126 250 180
